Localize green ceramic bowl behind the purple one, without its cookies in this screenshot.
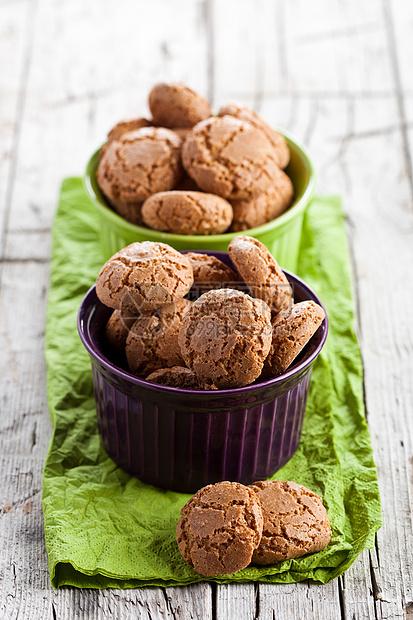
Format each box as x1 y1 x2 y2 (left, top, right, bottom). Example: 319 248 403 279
84 134 315 271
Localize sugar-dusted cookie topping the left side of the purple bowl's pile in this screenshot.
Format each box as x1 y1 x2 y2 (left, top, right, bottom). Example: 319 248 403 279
96 241 193 315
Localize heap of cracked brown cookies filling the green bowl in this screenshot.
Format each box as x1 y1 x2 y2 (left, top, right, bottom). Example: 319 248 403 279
96 83 294 235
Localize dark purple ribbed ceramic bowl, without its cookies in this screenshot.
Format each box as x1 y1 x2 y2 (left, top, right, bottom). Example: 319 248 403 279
78 252 328 493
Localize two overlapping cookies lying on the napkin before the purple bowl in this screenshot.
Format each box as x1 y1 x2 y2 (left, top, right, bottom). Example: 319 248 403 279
176 480 331 577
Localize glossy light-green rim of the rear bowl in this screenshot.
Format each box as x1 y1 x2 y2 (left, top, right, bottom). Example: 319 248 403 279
83 129 316 240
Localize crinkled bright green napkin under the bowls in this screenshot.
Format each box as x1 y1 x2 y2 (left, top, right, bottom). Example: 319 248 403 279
43 178 381 588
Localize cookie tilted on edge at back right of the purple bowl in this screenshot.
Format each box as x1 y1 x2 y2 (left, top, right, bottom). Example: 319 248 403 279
228 235 293 314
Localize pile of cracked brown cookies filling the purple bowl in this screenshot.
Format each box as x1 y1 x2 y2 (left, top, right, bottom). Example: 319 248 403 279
96 236 324 390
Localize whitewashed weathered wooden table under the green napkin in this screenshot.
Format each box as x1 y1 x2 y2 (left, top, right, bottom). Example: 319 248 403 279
0 0 413 620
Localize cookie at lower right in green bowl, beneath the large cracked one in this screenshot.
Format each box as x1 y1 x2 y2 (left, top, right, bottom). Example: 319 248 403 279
230 169 294 232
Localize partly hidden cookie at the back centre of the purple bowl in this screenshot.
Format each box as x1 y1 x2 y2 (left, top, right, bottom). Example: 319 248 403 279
185 252 240 294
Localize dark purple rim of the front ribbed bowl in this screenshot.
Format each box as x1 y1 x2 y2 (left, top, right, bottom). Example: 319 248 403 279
77 266 329 399
